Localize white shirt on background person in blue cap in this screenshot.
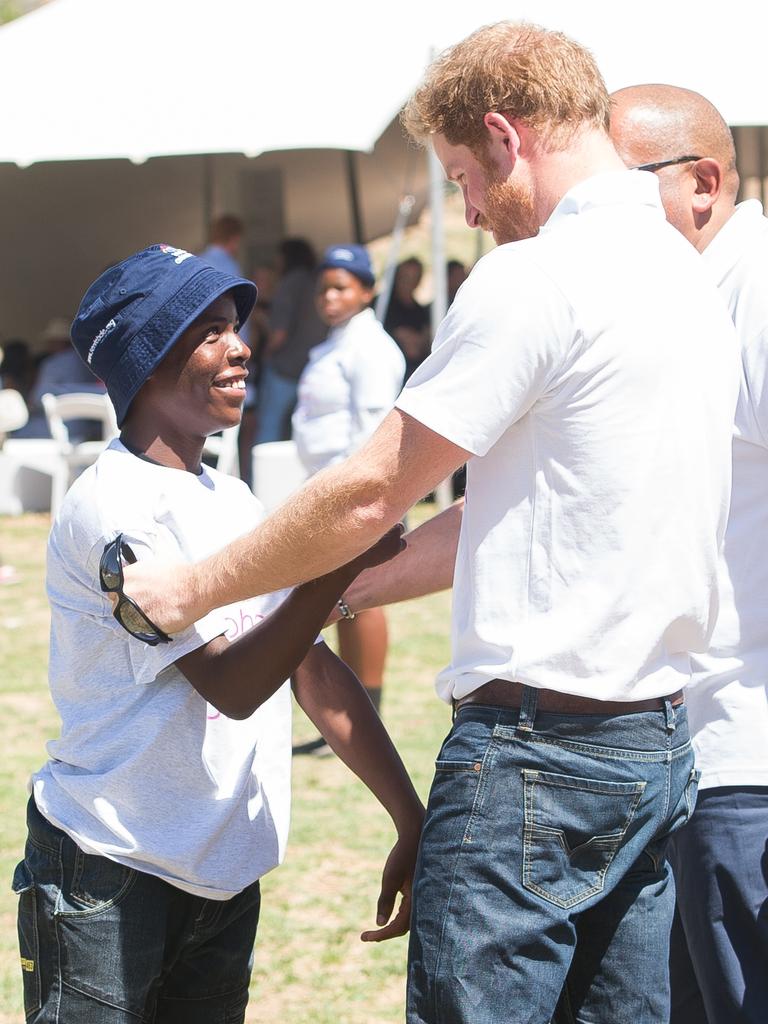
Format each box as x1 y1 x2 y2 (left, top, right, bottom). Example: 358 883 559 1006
293 309 406 474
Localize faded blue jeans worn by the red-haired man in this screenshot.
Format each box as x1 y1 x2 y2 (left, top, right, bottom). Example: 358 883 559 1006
407 687 697 1024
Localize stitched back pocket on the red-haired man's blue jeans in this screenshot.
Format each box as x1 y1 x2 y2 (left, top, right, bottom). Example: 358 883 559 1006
522 769 645 907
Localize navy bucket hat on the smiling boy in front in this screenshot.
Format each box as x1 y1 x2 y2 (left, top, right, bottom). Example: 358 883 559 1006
71 245 256 425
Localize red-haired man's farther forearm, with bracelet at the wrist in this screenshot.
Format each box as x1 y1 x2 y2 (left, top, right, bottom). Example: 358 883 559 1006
329 498 464 623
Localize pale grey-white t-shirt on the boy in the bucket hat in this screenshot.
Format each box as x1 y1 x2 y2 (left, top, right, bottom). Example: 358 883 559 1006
33 440 291 899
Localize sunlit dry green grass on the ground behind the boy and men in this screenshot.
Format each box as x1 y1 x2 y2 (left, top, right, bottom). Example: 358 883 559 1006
0 507 451 1024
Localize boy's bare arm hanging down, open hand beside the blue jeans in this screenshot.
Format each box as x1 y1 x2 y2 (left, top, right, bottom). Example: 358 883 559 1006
293 644 424 942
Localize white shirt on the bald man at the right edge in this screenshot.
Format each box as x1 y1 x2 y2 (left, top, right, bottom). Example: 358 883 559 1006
688 200 768 788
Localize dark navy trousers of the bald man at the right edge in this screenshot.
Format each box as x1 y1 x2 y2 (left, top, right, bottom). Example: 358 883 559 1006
669 786 768 1024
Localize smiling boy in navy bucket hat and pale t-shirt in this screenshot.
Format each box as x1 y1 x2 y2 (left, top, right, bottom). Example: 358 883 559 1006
13 246 422 1024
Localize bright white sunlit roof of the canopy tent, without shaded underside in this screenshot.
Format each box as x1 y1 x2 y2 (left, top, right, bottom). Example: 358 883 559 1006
0 0 768 165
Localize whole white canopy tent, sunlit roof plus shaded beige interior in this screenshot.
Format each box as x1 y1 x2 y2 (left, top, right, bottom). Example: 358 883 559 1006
0 0 768 344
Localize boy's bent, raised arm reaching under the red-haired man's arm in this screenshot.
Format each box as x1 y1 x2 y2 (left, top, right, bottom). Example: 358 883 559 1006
175 526 404 719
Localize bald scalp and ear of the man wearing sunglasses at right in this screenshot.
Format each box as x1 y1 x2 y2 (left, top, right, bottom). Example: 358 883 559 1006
610 85 738 251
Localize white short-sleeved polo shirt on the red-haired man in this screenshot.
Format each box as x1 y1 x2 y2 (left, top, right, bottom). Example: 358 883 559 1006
396 171 738 700
